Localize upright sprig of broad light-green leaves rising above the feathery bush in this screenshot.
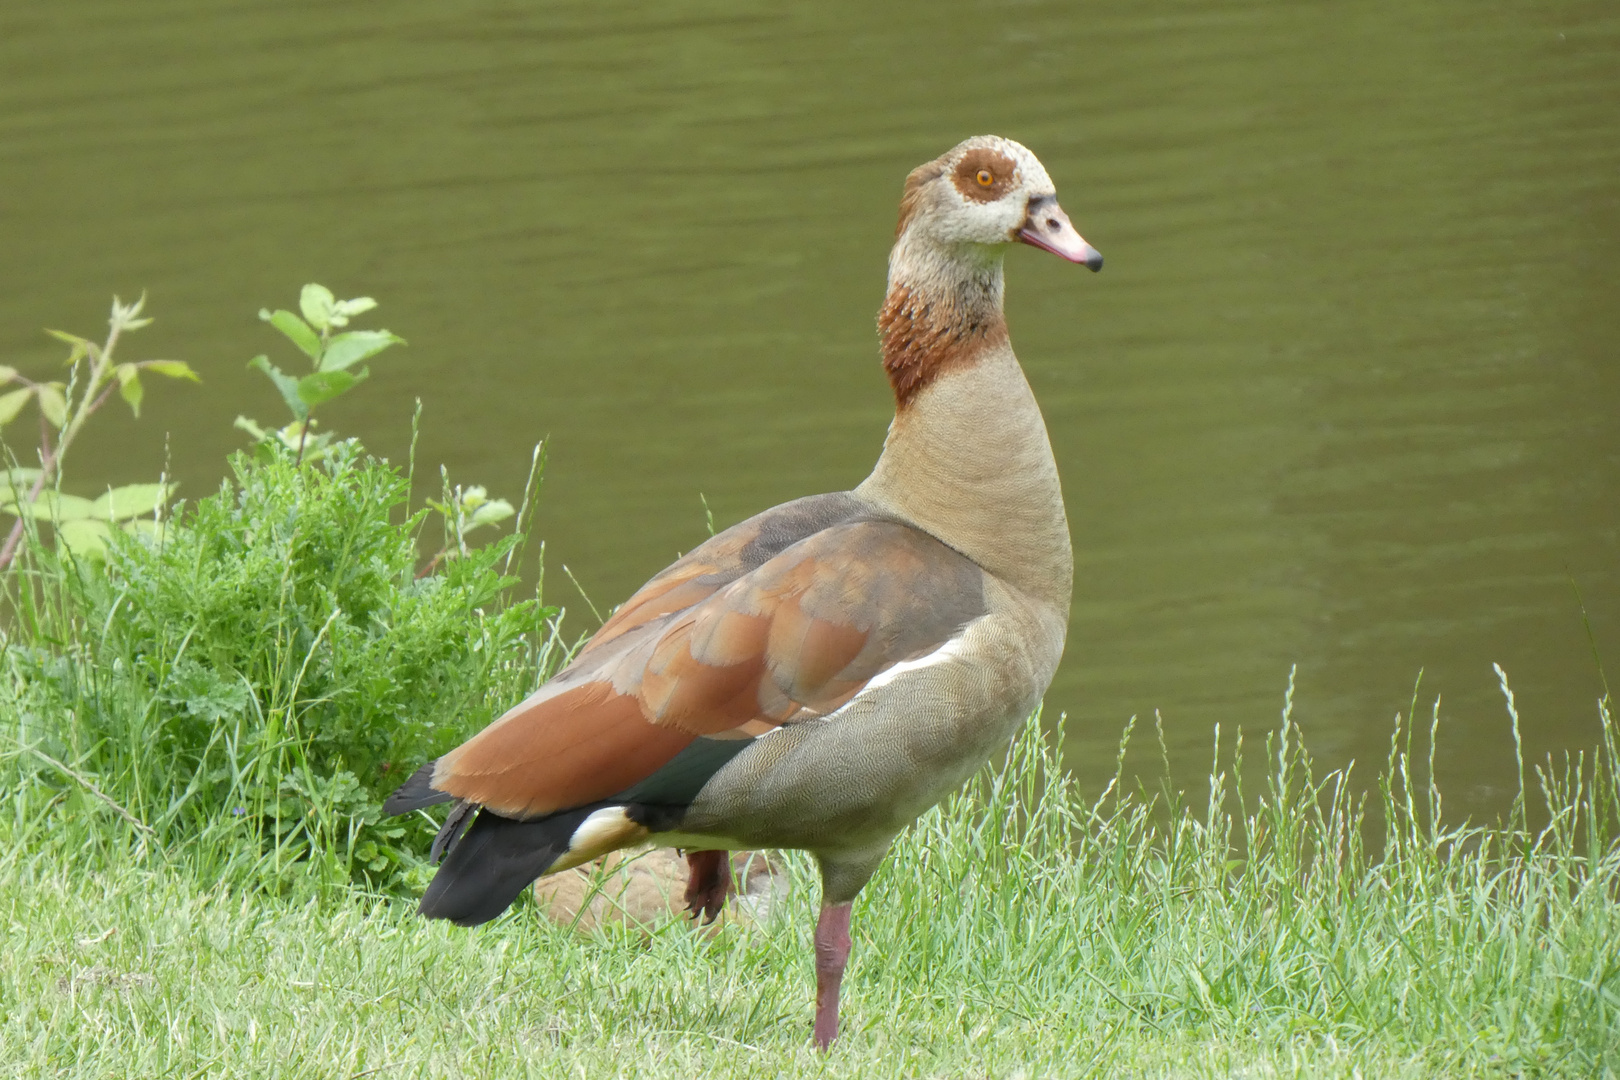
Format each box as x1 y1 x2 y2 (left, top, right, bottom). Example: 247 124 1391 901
237 283 405 461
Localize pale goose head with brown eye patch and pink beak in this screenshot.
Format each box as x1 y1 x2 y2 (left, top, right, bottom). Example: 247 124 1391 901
894 134 1103 270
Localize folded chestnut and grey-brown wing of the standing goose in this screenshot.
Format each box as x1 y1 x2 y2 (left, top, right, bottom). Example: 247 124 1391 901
433 495 983 818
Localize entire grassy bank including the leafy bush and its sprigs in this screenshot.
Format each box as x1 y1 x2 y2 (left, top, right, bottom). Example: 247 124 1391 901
0 287 1620 1078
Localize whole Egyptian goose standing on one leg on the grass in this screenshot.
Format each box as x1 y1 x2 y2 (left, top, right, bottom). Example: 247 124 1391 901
386 136 1103 1049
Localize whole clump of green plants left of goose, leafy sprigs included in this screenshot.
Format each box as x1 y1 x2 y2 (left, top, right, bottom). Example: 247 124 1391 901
0 285 565 887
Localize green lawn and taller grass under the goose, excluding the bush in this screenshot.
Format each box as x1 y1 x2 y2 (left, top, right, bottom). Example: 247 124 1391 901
0 702 1620 1077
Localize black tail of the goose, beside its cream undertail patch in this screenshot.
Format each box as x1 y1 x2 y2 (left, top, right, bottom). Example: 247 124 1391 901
418 803 606 926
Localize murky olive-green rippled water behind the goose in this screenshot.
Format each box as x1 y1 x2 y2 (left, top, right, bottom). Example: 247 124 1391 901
0 0 1620 811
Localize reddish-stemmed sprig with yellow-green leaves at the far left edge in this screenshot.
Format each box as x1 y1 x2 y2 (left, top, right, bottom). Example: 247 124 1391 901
0 295 198 570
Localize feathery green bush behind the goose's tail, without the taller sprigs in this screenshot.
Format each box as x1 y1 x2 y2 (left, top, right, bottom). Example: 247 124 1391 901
8 440 559 884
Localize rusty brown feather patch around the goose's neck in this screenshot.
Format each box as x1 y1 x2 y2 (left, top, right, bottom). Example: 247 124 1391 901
878 285 1008 408
